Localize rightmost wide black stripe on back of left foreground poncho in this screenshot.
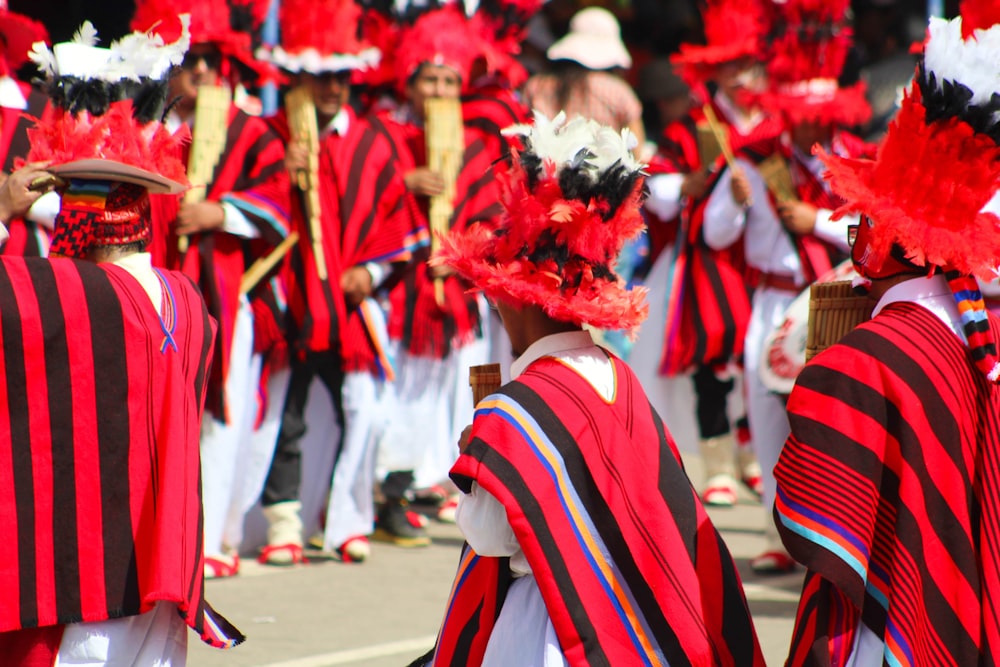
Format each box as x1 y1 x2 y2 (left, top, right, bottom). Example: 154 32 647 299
85 267 140 613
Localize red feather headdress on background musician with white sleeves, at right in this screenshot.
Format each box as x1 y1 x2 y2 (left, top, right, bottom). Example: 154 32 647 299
760 0 871 127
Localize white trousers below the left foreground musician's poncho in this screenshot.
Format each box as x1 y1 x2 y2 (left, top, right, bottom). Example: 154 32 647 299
54 602 189 667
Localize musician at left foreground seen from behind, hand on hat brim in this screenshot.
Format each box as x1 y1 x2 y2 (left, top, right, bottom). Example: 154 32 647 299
0 21 244 667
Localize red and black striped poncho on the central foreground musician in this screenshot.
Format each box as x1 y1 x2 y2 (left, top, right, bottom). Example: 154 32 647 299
434 357 764 667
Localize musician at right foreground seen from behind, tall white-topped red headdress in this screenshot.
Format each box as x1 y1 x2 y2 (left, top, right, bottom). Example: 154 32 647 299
775 13 1000 666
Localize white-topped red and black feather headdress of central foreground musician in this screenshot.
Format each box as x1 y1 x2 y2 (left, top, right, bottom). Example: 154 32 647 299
432 114 648 331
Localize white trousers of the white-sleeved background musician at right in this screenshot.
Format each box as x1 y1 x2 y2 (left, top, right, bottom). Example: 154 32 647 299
744 287 797 548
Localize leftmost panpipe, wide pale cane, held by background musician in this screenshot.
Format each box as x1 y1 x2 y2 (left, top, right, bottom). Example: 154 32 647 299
177 86 232 253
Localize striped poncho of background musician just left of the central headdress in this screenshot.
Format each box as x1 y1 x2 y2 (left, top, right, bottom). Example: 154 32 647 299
377 114 501 359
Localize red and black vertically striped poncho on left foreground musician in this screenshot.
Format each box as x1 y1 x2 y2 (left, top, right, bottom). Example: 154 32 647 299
0 257 243 647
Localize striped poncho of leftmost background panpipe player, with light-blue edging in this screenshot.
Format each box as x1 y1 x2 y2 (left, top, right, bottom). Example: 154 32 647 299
150 105 290 421
